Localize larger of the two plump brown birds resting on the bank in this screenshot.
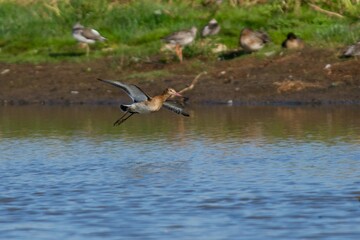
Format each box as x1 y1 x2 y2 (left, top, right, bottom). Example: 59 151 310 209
239 28 270 53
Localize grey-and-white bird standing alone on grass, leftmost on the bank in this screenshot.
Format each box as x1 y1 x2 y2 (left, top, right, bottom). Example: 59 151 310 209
72 23 106 56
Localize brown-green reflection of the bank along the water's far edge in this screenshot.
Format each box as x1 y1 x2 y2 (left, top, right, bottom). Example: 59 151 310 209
0 106 360 144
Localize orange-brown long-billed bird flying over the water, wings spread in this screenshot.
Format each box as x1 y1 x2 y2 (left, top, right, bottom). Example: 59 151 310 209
98 78 190 126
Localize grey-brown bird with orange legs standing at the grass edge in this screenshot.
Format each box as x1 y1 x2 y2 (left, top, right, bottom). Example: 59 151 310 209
163 27 197 62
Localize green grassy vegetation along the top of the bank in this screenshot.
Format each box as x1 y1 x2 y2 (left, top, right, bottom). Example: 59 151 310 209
0 0 360 62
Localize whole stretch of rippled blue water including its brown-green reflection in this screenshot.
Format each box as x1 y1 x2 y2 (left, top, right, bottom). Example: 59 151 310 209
0 106 360 239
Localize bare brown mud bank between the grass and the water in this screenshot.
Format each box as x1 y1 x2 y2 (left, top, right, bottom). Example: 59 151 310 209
0 48 360 105
